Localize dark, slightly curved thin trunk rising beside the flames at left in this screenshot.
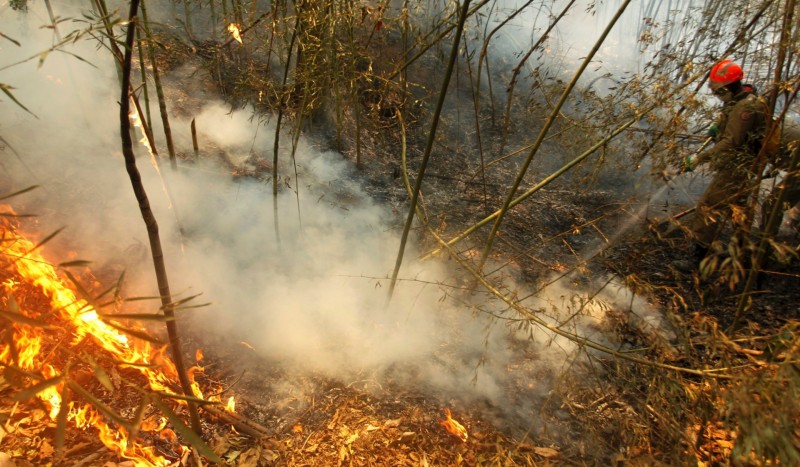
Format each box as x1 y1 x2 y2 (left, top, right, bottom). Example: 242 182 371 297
119 0 202 435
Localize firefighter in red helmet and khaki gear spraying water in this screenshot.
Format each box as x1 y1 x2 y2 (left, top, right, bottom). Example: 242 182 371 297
685 60 768 262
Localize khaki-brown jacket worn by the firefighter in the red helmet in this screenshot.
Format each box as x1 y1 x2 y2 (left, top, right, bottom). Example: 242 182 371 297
696 91 768 173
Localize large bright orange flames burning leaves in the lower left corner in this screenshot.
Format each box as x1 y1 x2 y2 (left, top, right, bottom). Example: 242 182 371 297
0 209 230 466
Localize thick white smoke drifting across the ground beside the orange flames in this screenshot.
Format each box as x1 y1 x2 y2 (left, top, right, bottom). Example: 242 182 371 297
0 2 672 438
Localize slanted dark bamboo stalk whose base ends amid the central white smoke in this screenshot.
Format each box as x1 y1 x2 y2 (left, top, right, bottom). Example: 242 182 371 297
386 0 470 306
